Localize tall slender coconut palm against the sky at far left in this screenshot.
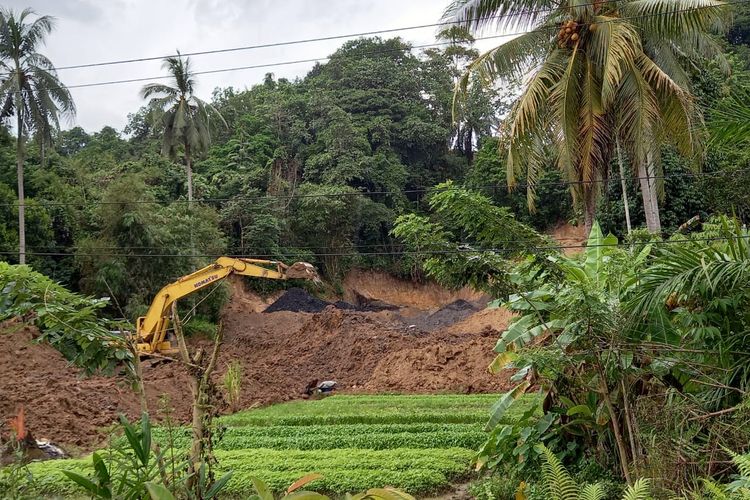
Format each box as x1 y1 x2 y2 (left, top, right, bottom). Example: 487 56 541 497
0 8 75 264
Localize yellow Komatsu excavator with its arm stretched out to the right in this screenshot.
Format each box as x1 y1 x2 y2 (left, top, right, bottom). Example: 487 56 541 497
135 257 320 356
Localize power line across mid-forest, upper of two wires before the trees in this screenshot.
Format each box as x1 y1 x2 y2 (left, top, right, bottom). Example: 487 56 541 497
0 168 750 209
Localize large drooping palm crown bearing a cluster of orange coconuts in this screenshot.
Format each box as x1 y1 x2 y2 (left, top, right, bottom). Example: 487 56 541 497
445 0 728 232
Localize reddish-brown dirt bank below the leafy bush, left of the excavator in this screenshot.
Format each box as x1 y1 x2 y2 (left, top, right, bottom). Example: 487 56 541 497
0 324 190 451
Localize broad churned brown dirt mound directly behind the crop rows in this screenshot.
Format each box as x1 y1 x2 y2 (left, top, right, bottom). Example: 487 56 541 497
221 303 508 406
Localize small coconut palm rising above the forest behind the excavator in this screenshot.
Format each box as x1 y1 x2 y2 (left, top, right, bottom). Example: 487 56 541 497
141 52 226 201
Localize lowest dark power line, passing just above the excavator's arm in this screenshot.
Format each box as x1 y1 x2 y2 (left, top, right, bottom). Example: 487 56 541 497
0 234 750 258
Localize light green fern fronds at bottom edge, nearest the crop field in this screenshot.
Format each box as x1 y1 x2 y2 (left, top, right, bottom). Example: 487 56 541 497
538 444 651 500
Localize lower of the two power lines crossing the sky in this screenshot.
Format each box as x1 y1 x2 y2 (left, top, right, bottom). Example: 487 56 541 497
7 0 750 93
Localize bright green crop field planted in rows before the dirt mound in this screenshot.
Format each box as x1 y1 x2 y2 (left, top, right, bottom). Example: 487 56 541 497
25 395 536 498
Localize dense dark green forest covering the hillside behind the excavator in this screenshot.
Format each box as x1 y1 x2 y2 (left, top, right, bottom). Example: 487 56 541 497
0 20 750 324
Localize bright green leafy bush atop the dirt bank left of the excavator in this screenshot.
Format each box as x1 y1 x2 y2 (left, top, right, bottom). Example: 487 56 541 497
0 262 132 373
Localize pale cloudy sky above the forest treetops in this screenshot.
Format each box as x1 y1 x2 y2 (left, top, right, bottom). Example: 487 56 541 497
3 0 500 131
